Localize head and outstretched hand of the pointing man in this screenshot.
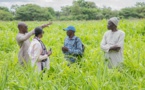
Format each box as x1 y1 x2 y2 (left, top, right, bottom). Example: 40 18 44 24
18 22 52 34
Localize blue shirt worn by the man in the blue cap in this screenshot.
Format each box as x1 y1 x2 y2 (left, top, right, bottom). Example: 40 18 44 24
63 36 83 63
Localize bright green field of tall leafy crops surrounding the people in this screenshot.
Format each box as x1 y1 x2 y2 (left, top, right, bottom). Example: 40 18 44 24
0 20 145 90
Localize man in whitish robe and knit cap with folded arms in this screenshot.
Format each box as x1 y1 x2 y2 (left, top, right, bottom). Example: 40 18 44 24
101 17 125 68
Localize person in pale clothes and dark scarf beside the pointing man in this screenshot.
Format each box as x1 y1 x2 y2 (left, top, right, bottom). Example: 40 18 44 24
28 27 52 72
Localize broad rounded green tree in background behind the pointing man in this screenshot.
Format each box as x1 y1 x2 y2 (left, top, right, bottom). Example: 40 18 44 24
16 4 52 21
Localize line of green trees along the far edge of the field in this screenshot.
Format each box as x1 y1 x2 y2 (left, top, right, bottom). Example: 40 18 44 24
0 0 145 21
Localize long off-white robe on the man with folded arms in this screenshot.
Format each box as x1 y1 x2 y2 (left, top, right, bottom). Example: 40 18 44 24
101 30 125 66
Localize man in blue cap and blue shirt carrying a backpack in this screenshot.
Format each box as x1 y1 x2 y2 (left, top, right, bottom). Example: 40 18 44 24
62 26 84 65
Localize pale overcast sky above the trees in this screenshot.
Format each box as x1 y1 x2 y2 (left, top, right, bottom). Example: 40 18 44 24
0 0 145 10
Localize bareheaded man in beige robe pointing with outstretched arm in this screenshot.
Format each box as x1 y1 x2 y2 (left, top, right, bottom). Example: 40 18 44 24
16 22 52 66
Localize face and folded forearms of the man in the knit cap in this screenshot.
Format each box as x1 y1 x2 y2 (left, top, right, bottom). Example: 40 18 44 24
107 21 121 51
